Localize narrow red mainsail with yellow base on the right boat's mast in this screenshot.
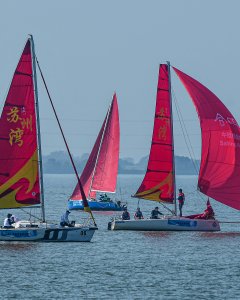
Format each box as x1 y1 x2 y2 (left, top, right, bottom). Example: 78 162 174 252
135 64 174 203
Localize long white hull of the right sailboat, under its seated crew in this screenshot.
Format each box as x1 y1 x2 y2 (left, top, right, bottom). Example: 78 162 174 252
111 217 220 231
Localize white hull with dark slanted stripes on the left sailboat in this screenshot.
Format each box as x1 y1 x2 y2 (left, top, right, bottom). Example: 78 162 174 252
0 221 97 242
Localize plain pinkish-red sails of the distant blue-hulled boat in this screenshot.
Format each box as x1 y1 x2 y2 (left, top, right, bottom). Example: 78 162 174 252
71 94 120 200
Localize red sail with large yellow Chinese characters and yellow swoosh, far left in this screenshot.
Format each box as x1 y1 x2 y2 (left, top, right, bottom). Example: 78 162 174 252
0 40 40 208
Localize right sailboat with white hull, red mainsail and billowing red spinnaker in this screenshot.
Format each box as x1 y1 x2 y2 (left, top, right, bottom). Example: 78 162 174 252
110 63 240 231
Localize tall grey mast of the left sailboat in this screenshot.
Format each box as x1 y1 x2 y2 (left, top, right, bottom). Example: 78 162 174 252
30 34 46 222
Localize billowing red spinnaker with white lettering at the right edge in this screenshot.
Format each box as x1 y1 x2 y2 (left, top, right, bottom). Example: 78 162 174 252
174 68 240 210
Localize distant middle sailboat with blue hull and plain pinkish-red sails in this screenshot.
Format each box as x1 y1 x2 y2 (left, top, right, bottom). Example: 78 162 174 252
68 93 122 211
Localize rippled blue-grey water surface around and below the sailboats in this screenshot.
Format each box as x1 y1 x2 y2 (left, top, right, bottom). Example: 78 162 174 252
0 175 240 299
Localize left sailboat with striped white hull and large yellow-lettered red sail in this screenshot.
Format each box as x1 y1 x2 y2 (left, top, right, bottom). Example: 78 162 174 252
0 36 97 242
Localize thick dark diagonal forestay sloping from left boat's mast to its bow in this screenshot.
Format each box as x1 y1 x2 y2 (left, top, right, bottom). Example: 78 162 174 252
35 55 97 227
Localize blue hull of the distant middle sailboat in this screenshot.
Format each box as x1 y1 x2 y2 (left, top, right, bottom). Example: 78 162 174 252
68 200 123 211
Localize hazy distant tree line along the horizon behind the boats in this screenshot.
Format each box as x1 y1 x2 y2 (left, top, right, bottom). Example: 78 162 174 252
43 151 199 175
